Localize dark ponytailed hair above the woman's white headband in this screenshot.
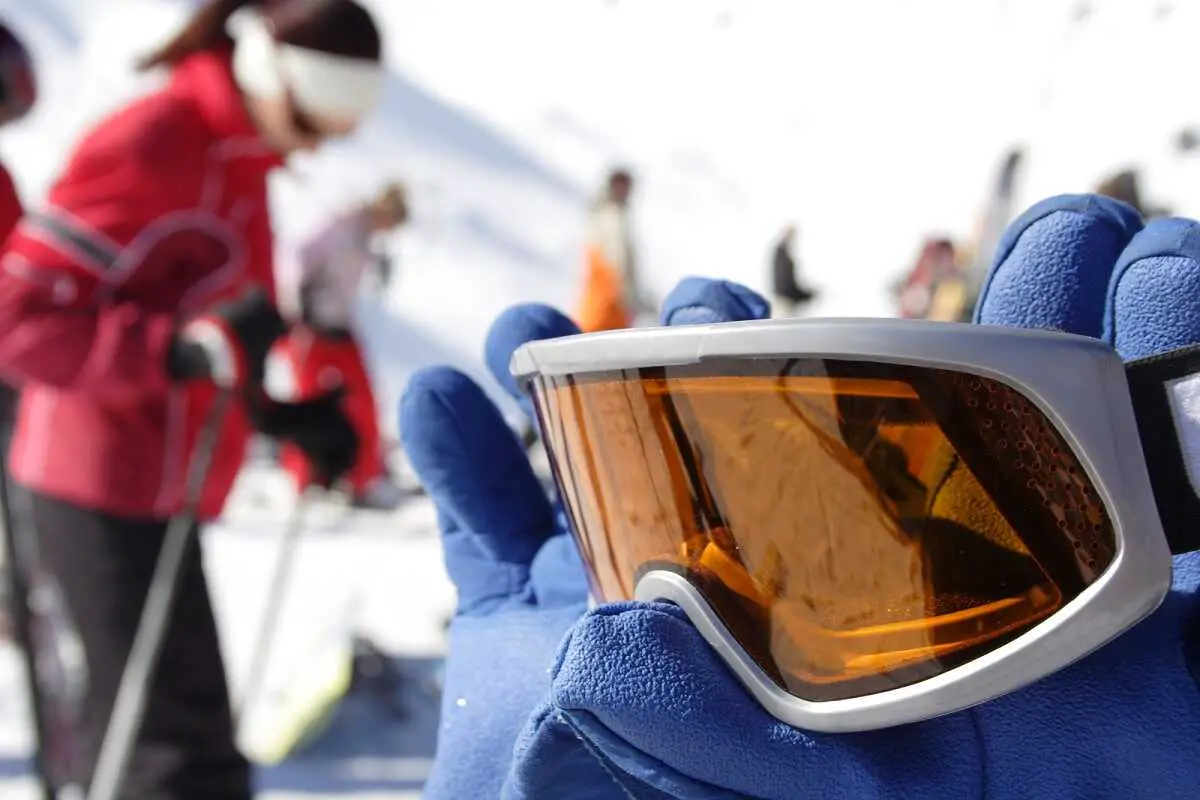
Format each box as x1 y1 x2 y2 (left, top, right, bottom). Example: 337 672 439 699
137 0 383 71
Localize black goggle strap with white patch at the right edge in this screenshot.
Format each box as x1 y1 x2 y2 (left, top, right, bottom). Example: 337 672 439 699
1126 345 1200 555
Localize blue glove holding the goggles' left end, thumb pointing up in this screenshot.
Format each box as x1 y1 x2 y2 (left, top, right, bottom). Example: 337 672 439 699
400 279 768 800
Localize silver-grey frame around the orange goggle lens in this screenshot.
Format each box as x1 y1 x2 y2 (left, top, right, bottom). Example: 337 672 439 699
511 319 1200 733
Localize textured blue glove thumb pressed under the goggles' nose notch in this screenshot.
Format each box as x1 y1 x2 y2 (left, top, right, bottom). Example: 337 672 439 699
530 603 982 800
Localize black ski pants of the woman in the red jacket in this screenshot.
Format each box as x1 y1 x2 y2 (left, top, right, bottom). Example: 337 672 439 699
32 493 251 800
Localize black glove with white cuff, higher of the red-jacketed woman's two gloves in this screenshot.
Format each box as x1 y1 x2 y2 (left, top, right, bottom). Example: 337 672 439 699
167 285 287 389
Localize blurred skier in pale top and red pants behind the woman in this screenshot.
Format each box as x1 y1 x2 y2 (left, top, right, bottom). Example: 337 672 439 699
280 184 408 509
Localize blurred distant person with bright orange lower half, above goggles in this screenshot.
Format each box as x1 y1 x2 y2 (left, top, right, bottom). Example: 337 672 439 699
576 169 655 333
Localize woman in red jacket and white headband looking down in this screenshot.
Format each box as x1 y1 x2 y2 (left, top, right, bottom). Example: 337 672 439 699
0 0 384 799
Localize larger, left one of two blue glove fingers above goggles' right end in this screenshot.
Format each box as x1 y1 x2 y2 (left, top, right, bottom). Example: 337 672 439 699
974 194 1142 337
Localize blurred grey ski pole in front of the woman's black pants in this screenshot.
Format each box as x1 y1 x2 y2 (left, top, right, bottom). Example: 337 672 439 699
86 391 233 800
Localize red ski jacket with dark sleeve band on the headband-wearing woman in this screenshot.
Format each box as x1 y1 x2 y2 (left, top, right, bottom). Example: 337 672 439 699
0 50 282 519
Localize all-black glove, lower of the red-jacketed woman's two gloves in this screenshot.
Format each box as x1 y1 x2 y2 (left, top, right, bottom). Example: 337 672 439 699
246 386 359 488
